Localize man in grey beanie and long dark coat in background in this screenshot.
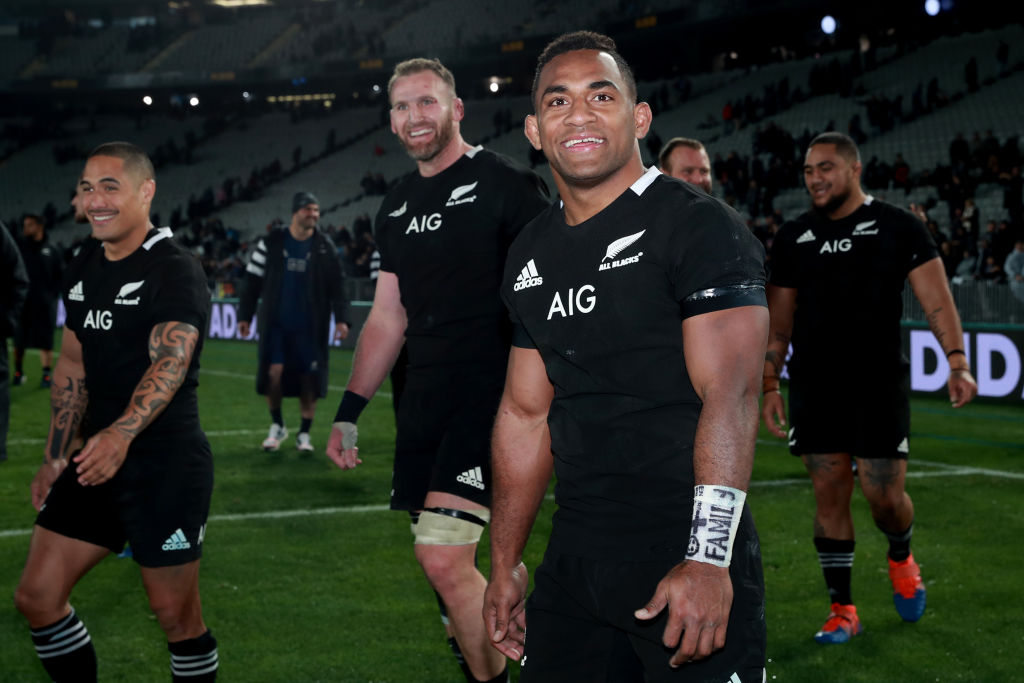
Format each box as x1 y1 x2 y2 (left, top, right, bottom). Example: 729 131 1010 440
239 191 348 452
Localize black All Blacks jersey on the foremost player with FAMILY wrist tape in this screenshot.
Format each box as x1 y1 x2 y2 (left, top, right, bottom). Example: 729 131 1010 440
502 168 766 557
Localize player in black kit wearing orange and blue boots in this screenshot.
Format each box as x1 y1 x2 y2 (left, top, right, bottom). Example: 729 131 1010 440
762 133 978 644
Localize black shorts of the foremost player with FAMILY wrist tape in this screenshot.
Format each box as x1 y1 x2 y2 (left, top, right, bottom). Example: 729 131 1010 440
519 510 766 683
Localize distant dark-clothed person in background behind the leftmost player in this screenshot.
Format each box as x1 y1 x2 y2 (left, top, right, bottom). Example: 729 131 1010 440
14 214 63 389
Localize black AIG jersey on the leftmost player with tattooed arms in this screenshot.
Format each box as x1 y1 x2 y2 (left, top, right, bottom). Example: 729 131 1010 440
63 227 210 445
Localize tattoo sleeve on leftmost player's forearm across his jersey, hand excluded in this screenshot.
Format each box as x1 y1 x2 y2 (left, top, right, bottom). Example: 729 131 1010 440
112 323 199 440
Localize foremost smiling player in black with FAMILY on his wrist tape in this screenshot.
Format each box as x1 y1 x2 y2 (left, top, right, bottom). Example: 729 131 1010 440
484 32 768 683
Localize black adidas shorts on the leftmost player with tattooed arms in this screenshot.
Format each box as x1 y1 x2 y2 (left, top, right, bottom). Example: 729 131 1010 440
36 434 213 567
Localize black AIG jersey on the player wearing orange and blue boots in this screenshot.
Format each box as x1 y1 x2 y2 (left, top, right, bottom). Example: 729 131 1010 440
771 197 939 391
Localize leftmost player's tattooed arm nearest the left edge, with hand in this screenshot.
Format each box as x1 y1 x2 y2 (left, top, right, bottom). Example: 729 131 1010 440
32 328 89 510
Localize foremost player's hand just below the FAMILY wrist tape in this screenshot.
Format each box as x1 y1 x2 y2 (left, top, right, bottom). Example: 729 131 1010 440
634 561 732 668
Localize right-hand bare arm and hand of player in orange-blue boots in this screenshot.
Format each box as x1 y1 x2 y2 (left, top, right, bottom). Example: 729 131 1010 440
908 257 978 408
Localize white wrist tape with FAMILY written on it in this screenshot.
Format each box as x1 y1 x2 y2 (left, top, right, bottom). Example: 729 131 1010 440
686 484 746 567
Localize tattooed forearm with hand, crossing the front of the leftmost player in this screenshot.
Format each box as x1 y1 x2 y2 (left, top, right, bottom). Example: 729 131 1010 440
72 323 199 486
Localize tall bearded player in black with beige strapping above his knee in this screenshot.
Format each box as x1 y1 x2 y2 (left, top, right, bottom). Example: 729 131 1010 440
328 58 548 682
